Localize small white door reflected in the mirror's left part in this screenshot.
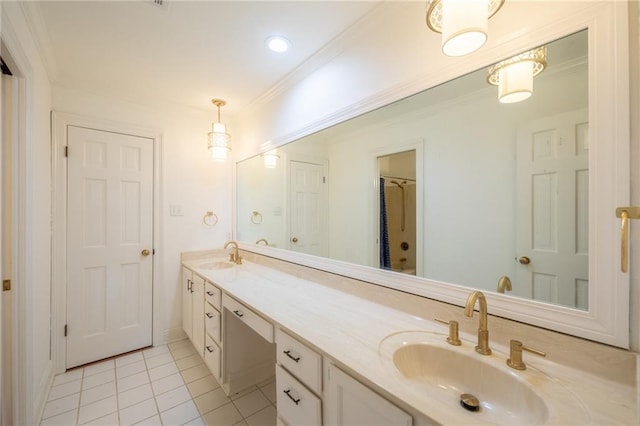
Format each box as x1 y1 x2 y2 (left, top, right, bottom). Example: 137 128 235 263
289 161 328 256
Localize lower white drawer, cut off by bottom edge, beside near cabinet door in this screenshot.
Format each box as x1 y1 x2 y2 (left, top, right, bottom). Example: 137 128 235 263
276 365 322 425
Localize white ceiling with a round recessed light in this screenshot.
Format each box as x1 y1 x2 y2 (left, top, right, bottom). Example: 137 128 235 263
30 0 379 114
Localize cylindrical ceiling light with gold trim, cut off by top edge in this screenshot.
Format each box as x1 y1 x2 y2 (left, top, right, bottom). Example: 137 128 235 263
426 0 504 56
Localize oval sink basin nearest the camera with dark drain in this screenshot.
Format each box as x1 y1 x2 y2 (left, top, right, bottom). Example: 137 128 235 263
380 331 588 425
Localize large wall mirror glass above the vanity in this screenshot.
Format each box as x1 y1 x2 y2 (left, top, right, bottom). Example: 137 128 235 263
236 5 628 346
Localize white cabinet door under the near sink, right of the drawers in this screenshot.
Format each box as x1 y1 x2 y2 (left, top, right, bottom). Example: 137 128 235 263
324 364 413 426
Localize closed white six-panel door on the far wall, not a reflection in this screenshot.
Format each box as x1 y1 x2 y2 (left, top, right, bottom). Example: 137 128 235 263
66 126 153 368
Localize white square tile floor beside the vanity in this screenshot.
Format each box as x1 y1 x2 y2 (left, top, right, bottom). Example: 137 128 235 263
40 340 276 426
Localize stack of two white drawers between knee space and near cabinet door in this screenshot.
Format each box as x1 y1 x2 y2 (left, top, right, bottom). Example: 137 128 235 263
276 329 322 426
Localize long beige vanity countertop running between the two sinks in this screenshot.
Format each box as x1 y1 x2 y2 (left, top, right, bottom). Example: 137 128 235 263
182 251 638 425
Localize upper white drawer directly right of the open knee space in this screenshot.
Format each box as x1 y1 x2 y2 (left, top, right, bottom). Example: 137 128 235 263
276 329 322 394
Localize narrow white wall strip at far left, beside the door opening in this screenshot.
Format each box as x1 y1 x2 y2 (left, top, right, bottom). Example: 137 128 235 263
2 2 52 424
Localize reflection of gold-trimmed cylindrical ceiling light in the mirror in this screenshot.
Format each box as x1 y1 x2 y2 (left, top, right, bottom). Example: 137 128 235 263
487 46 547 104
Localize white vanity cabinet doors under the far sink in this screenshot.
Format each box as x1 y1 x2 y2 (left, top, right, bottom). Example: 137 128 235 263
182 267 205 356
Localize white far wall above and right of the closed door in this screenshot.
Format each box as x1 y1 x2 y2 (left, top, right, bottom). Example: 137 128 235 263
53 87 232 344
